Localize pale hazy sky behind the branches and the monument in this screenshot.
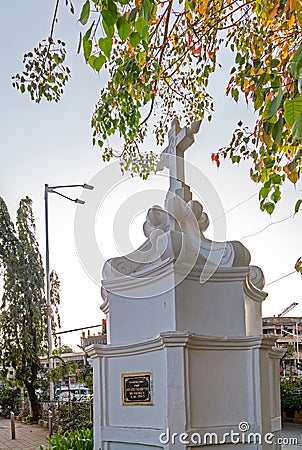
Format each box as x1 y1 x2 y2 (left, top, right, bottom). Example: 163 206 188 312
0 0 302 348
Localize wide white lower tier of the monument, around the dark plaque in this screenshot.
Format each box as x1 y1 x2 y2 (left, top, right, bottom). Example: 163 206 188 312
88 332 283 450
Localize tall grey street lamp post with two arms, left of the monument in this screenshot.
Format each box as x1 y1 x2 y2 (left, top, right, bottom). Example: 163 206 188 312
44 183 94 401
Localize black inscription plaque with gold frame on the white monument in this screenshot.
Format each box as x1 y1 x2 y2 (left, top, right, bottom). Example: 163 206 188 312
122 372 153 406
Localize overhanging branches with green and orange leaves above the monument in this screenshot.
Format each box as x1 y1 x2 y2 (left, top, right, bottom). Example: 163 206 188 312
13 0 302 214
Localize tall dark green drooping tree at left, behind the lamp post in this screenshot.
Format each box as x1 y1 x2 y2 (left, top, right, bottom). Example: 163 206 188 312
0 197 59 420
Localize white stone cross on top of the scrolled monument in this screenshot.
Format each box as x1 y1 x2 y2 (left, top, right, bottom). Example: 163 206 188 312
156 119 201 200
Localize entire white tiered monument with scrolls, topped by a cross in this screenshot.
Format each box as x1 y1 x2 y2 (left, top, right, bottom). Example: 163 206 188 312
87 121 283 450
